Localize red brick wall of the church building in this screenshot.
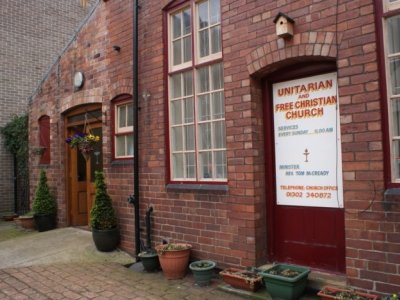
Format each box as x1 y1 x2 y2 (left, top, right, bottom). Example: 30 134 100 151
31 0 400 293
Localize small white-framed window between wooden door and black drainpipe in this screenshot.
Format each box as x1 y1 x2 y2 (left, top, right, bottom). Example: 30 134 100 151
114 101 133 158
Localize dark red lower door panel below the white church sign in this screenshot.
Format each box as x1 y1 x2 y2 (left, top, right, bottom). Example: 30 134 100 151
274 205 345 272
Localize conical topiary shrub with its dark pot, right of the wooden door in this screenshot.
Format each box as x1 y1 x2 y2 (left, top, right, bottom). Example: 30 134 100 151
90 171 119 252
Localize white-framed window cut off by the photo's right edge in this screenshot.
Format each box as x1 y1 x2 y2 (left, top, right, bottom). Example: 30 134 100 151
383 0 400 183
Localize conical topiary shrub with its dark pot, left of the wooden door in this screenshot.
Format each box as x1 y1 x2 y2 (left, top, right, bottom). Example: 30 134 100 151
32 170 57 232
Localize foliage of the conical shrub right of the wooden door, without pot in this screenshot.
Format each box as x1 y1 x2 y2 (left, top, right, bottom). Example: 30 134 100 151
90 171 117 230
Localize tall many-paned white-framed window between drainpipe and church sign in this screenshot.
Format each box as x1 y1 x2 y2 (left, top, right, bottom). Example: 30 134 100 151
168 0 227 182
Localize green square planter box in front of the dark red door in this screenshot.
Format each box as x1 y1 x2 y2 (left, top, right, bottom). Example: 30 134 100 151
259 264 310 300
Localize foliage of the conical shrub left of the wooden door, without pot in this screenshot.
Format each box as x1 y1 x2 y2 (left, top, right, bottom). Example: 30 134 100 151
32 170 57 215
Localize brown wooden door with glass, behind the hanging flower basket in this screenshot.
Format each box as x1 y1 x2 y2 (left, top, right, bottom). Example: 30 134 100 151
65 105 103 226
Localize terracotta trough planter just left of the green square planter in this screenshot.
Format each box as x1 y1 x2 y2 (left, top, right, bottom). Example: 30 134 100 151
219 268 262 292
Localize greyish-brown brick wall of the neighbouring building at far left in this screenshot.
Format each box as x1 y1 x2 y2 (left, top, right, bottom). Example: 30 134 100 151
0 0 95 215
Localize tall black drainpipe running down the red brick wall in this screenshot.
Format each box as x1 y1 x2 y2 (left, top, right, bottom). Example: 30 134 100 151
128 0 140 257
